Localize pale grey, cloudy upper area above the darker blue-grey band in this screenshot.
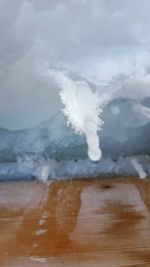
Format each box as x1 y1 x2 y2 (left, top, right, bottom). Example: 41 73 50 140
0 0 150 129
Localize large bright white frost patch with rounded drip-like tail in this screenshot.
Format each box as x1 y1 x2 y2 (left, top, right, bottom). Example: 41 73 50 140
49 70 103 161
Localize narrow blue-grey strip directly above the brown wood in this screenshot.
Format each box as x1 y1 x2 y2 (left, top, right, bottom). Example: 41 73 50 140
0 155 150 181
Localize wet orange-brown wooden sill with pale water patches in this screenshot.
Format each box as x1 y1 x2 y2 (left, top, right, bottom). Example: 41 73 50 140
0 178 150 267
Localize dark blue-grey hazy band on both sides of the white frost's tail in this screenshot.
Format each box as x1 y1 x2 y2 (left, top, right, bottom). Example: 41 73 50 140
0 99 150 163
